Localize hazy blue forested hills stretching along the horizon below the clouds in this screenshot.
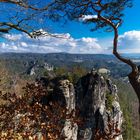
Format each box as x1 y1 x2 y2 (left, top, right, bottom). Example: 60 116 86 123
0 53 135 77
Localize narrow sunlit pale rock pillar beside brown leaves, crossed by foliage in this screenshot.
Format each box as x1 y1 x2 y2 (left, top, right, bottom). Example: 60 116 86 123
58 80 78 140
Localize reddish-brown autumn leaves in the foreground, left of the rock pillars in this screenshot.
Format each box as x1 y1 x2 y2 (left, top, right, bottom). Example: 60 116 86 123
0 84 66 140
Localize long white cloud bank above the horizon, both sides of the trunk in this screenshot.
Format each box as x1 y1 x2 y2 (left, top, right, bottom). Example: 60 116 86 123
0 30 140 54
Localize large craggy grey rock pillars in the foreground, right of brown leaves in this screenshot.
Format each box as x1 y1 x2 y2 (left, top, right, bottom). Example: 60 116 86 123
59 72 123 140
